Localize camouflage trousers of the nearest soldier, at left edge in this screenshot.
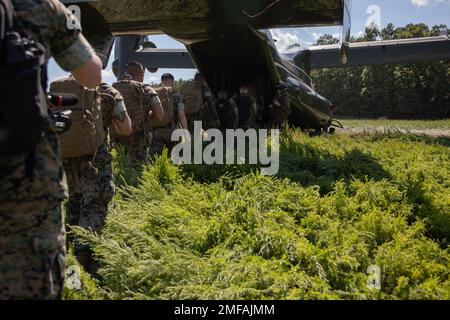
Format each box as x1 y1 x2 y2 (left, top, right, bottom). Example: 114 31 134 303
0 135 66 300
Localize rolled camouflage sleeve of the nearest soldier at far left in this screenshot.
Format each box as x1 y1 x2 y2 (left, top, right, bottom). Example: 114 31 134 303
48 0 94 71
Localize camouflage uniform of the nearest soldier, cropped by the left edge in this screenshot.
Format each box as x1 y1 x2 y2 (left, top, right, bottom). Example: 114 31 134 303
0 0 93 299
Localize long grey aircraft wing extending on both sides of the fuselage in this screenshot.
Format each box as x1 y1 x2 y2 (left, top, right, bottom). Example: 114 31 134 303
118 36 450 69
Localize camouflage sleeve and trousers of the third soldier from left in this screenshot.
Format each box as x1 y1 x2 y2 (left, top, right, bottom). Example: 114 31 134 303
119 83 160 165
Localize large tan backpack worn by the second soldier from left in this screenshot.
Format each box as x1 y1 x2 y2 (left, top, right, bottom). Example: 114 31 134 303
50 77 106 159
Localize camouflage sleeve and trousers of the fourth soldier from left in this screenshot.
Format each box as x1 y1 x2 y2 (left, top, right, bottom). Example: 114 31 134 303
150 92 184 157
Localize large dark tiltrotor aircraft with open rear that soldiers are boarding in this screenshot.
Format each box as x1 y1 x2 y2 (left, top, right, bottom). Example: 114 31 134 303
62 0 450 132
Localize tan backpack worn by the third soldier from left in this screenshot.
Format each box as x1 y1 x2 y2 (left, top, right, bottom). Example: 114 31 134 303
112 80 145 132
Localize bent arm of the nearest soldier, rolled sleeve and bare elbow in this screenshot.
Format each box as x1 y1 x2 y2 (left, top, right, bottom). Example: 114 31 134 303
48 0 102 89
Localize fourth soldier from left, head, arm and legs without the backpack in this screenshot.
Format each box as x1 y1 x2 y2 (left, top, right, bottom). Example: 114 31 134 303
150 73 188 157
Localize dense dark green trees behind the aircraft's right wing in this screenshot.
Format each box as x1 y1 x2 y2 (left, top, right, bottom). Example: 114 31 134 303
312 24 450 119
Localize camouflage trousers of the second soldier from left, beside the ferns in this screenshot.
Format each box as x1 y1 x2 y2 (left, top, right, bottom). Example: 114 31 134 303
64 145 114 253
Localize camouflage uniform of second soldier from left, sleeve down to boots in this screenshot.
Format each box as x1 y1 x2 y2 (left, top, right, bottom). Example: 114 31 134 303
64 83 126 268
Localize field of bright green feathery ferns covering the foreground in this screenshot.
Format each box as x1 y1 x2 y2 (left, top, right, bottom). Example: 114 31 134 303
64 121 450 299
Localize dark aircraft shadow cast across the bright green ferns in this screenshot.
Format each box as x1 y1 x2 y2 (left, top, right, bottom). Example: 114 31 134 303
183 139 391 194
